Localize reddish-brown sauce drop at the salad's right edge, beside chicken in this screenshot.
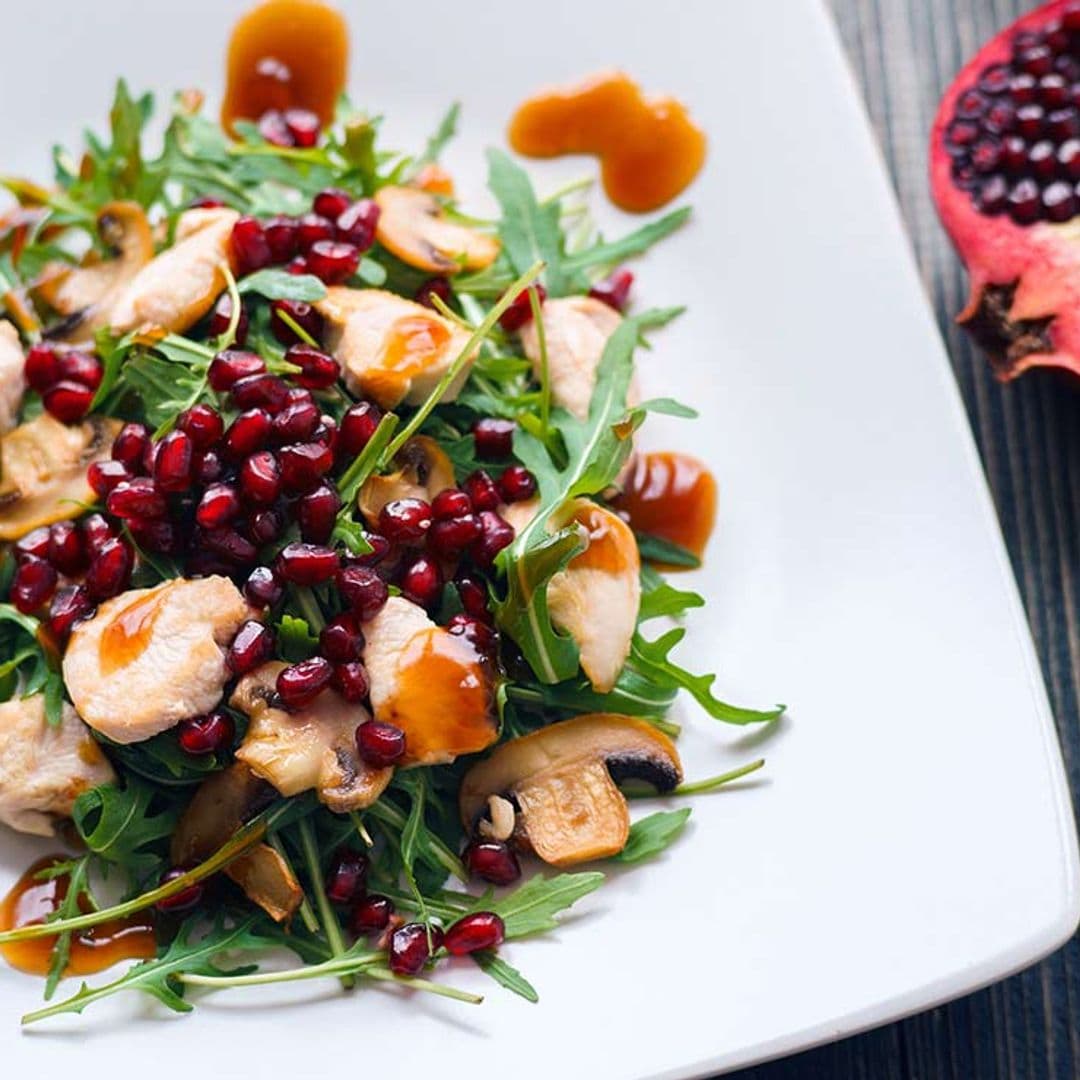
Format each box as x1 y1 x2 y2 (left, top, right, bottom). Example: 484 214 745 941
612 450 716 569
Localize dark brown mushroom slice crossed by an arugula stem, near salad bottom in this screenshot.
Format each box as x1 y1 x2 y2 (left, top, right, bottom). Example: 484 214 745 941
172 761 303 922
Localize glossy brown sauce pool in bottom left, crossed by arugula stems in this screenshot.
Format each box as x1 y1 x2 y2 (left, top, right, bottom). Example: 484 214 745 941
0 855 158 975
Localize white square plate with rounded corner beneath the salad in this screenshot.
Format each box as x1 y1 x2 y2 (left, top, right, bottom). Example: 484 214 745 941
0 0 1080 1080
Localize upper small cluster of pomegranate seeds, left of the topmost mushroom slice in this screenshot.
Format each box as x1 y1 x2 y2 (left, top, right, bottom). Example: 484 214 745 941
226 185 379 287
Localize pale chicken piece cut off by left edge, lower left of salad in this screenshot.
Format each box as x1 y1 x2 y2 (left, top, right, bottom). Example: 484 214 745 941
0 693 116 836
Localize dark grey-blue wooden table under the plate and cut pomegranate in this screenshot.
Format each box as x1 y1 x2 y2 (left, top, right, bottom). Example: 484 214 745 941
725 0 1080 1080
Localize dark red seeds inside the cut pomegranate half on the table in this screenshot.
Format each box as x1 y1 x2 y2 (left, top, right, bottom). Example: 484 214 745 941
945 2 1080 225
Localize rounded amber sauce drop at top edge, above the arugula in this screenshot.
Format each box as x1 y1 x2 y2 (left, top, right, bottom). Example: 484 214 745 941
221 0 349 131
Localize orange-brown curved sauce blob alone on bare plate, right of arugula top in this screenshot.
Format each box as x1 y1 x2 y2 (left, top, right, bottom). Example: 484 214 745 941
509 71 705 212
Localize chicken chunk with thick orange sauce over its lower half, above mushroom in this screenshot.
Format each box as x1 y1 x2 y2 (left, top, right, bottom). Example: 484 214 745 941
364 596 499 765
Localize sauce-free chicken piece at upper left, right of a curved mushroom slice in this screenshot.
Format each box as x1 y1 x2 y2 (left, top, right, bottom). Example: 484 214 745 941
108 207 240 333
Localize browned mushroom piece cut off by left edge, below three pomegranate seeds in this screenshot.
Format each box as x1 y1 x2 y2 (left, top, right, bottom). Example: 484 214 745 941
0 413 120 540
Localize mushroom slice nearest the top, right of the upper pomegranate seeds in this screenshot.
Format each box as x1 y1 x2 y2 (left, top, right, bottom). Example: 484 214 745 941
375 187 499 273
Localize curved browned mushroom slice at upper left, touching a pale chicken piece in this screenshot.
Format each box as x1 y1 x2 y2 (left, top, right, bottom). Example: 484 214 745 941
35 202 153 341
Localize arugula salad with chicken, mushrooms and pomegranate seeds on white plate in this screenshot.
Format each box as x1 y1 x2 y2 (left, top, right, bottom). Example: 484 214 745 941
0 8 782 1023
